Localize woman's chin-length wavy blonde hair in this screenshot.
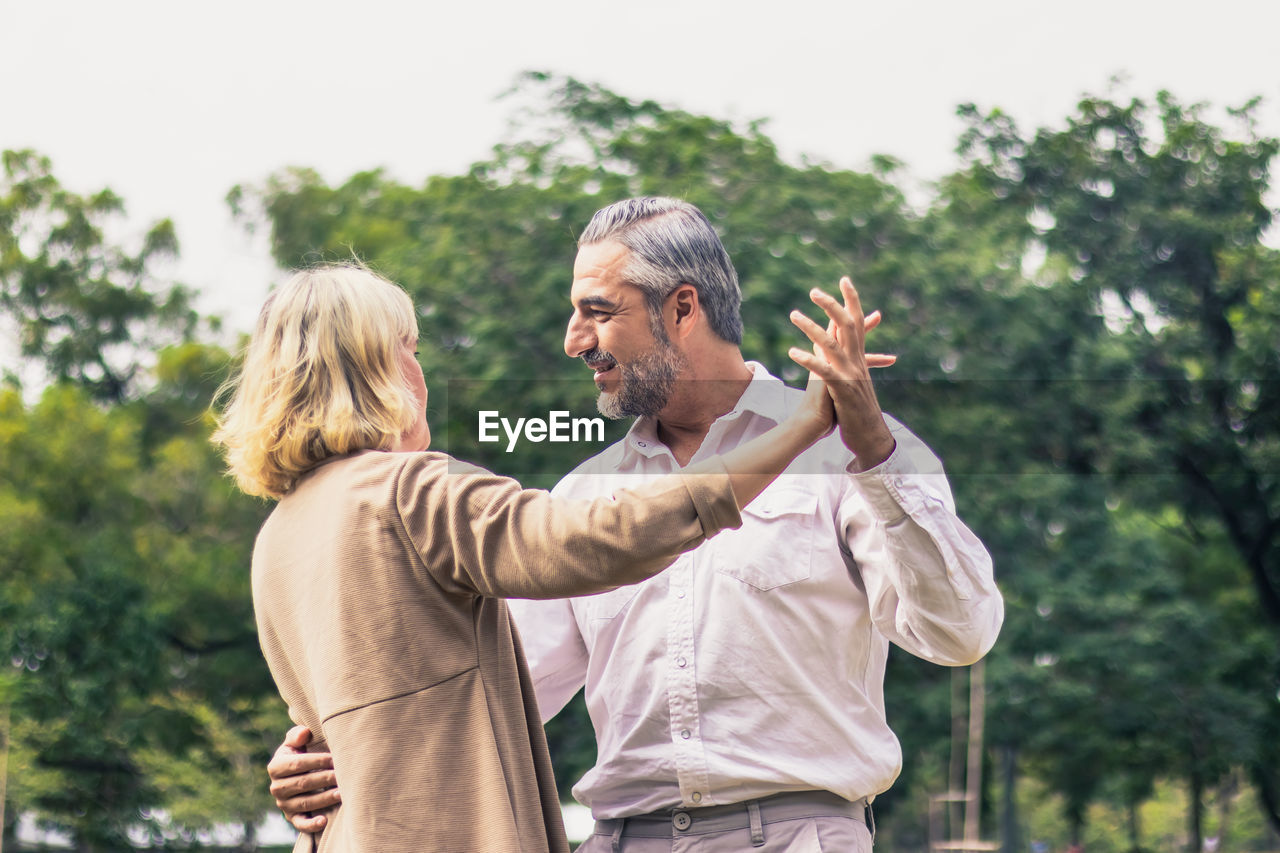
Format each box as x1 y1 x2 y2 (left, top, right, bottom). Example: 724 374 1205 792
212 264 419 498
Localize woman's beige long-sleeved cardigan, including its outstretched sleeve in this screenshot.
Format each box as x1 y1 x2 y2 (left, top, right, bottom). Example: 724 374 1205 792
253 451 741 853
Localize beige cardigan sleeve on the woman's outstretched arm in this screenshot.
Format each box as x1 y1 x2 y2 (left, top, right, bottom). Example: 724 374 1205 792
396 452 741 598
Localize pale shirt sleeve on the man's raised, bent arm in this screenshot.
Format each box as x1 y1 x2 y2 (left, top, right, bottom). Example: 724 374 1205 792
840 416 1005 666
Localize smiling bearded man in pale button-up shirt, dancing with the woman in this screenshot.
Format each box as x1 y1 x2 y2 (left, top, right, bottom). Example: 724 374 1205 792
271 199 1004 853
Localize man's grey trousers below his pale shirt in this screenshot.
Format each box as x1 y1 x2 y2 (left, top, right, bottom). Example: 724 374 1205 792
577 790 873 853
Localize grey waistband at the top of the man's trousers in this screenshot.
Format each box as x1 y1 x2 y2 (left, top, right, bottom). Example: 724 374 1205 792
595 790 868 839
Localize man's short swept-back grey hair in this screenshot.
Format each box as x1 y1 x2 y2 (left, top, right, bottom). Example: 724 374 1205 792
577 197 742 343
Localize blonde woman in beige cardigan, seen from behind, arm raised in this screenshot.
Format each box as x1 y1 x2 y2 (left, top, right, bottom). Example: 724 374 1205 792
214 266 832 853
